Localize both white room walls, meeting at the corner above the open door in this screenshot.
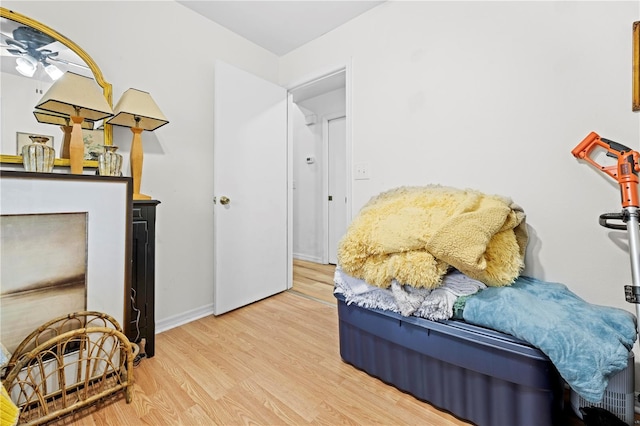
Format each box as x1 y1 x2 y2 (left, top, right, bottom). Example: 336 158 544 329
2 0 640 340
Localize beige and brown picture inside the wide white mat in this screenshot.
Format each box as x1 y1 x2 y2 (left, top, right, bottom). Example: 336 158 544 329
0 213 87 352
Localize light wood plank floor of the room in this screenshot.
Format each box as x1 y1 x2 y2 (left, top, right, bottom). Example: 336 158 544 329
50 262 582 426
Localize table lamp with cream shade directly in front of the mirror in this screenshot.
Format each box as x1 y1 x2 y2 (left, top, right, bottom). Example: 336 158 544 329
36 71 113 174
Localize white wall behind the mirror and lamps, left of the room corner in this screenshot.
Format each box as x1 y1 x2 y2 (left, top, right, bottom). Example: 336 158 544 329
2 0 278 329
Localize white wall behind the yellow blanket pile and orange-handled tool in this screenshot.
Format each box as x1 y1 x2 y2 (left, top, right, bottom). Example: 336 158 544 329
280 1 640 312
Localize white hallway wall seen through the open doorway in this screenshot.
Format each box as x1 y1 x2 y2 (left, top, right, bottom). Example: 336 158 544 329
292 89 346 263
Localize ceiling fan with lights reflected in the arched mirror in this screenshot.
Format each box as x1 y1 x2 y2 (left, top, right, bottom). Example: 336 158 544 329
2 26 87 80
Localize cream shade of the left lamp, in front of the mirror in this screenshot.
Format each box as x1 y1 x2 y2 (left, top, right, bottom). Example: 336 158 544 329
36 71 113 121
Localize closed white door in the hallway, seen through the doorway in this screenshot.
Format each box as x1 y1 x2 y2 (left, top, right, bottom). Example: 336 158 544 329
328 117 347 264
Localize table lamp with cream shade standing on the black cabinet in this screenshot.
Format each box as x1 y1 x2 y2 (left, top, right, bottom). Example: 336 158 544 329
107 89 169 200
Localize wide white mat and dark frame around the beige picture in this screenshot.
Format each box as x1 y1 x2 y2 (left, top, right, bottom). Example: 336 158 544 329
0 170 133 336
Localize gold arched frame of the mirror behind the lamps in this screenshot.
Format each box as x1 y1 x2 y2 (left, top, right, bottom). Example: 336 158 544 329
0 7 113 167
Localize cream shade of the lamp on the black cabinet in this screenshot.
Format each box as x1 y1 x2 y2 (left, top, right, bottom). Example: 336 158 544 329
107 89 169 131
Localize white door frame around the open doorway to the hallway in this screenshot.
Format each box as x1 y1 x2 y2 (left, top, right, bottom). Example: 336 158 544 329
285 58 353 280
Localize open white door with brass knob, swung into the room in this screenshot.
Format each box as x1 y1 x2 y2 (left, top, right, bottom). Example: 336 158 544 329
213 61 288 315
